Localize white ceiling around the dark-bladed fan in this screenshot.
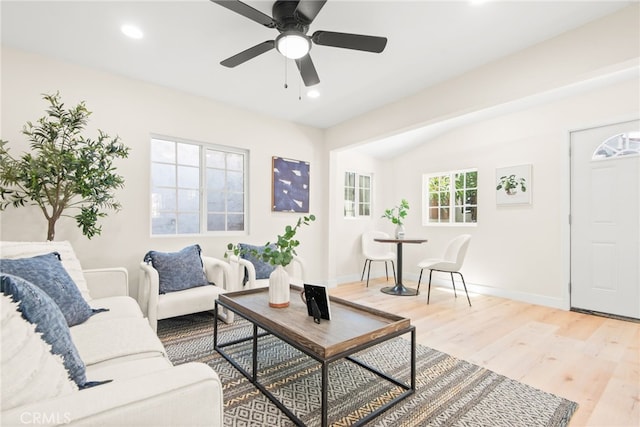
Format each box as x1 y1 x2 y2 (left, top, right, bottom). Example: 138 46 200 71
0 0 634 134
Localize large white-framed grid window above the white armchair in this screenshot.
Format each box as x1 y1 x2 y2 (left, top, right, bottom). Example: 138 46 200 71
151 138 248 236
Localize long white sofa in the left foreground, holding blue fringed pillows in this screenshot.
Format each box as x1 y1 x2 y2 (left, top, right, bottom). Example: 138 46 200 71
0 242 223 426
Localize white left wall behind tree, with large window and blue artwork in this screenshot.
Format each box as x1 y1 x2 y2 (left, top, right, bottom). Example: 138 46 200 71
0 48 328 295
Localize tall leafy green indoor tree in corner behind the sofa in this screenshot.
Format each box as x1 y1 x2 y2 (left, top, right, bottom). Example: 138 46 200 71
0 92 129 240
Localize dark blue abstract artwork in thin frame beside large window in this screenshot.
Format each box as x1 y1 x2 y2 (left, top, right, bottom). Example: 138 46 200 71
271 157 309 213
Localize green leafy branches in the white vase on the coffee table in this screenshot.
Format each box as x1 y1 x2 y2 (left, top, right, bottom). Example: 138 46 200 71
225 214 316 267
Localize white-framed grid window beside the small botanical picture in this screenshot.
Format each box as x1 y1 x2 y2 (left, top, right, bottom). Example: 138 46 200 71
422 169 478 225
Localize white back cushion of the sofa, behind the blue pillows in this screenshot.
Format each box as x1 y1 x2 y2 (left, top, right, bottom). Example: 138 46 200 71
0 241 91 301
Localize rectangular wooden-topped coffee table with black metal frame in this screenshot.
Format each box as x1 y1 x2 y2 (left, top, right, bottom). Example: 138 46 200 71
214 285 416 427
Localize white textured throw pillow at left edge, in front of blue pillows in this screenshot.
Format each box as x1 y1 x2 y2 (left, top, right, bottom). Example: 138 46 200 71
0 294 77 411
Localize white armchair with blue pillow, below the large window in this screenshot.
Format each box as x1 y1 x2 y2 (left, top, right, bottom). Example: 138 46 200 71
138 256 234 332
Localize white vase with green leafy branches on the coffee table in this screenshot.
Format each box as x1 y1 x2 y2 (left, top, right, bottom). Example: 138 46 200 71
225 214 316 308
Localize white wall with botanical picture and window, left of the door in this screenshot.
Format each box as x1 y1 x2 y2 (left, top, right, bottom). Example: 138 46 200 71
393 80 640 308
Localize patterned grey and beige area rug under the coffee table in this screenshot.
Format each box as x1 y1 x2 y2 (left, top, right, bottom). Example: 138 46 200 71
158 313 577 427
